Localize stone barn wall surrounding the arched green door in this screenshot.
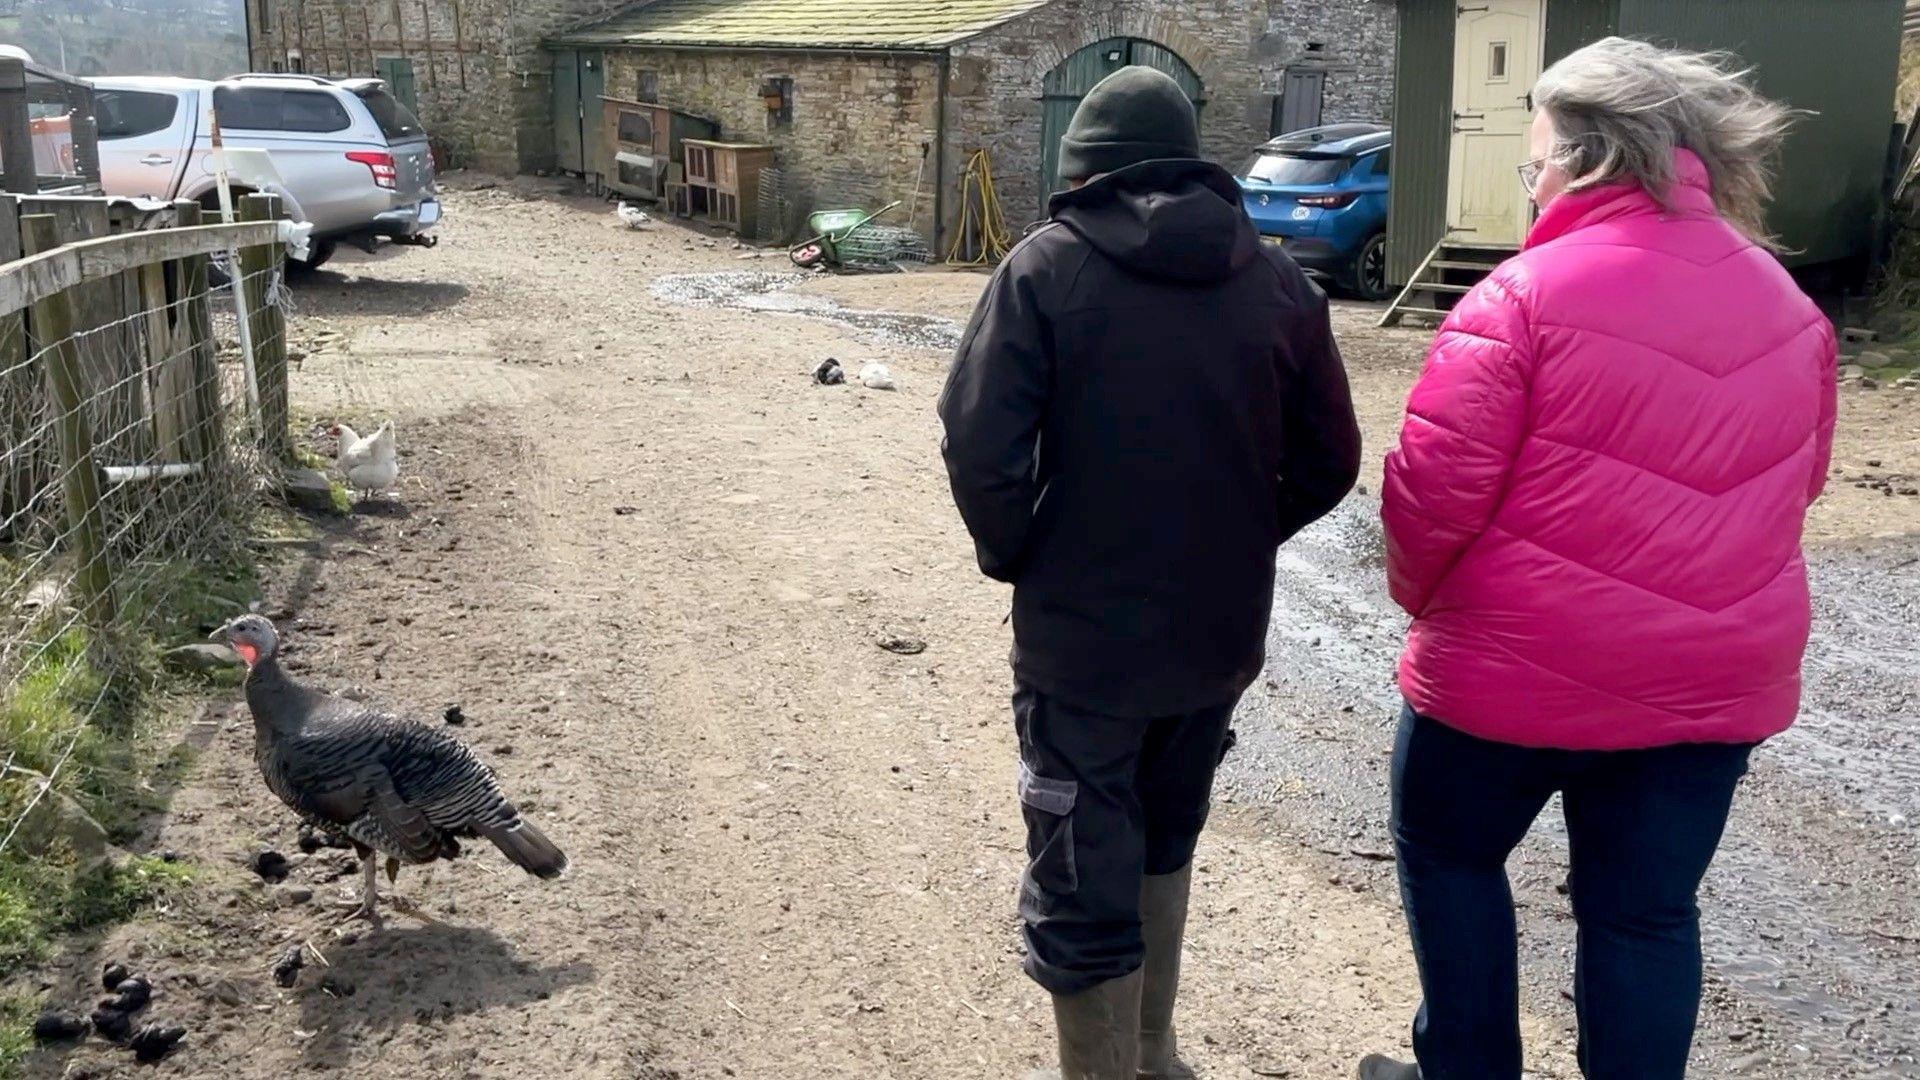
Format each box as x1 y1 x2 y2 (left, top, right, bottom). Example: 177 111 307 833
948 0 1394 223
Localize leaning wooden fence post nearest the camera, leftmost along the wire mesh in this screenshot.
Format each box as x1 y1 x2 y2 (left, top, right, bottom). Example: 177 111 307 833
19 213 115 626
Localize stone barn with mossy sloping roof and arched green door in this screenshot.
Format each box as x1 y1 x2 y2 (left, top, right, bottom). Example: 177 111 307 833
549 0 1396 248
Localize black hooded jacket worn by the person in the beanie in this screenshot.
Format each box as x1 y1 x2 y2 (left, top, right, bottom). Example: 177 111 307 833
941 161 1359 717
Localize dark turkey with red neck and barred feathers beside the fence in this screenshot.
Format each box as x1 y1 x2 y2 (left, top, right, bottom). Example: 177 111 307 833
219 615 566 926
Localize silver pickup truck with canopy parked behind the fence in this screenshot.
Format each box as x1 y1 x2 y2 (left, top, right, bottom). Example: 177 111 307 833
90 75 440 269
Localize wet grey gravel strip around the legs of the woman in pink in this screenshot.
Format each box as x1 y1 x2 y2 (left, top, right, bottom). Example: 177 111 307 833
1221 498 1920 1076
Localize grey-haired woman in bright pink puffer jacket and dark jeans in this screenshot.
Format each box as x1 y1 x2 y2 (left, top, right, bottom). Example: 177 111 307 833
1361 38 1836 1080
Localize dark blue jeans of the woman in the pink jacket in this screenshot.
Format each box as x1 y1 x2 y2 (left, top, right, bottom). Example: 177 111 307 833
1392 709 1753 1080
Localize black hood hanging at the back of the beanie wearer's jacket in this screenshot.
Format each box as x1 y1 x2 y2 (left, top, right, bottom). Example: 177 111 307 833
1048 160 1260 282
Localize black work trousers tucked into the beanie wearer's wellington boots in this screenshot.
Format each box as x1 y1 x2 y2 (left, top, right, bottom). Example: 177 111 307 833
1014 686 1236 994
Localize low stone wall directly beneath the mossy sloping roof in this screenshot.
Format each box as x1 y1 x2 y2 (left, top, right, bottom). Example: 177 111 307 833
591 48 939 234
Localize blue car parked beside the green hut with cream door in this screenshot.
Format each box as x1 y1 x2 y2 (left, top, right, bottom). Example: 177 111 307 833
1240 123 1394 300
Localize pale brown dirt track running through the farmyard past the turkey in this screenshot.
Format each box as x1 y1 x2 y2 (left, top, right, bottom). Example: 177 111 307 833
18 180 1914 1080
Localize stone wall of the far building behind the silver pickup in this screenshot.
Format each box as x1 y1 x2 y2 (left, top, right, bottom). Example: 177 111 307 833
248 0 620 173
